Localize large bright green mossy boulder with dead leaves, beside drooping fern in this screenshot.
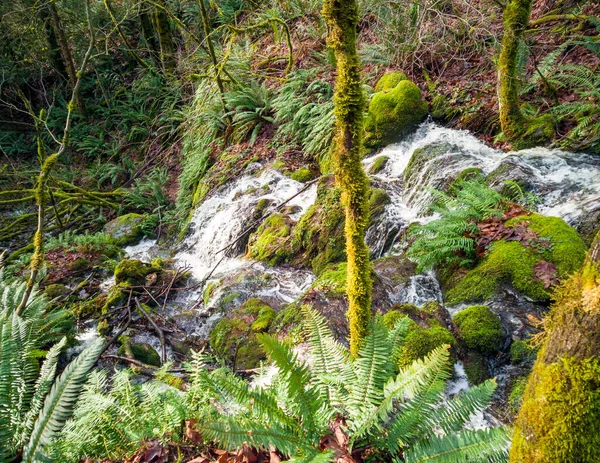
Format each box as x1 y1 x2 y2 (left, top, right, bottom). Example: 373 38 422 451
446 214 586 304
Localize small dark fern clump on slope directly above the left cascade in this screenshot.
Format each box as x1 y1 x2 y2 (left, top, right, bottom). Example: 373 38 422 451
224 80 274 146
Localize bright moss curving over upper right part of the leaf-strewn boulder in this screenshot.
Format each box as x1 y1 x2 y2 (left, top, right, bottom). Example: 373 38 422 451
506 214 587 278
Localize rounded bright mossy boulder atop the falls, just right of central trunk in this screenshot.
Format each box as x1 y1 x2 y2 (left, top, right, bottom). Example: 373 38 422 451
365 79 428 148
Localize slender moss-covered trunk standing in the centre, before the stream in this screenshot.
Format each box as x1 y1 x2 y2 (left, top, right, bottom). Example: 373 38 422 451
323 0 373 355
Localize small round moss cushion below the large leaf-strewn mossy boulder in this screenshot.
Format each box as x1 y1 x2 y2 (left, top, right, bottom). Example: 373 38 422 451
454 305 504 355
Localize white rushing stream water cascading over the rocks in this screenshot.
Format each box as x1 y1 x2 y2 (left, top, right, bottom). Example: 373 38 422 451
118 122 600 427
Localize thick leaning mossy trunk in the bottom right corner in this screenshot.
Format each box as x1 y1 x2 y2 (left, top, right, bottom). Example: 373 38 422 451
510 233 600 463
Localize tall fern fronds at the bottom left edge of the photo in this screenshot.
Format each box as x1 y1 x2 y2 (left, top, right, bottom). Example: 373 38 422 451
0 273 103 462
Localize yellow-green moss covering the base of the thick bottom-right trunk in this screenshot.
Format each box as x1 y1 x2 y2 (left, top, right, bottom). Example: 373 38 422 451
510 357 600 463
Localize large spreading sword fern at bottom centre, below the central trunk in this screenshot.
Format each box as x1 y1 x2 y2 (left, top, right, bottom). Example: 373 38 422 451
196 307 508 462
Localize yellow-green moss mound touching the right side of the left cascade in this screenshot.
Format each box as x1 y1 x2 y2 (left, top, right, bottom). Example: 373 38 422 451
247 214 294 265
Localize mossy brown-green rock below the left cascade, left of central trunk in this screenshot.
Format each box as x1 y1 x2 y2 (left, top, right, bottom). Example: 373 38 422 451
210 298 276 369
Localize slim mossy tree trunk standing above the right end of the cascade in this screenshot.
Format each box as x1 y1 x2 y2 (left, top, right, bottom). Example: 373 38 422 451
498 0 532 142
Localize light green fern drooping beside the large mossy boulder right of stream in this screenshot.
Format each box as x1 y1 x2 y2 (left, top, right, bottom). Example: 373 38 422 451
407 178 505 271
